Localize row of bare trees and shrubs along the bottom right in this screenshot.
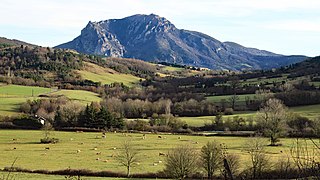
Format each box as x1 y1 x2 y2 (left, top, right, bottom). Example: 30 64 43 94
164 137 320 179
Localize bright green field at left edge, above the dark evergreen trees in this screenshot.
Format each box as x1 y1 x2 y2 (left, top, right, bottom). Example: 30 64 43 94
0 85 101 116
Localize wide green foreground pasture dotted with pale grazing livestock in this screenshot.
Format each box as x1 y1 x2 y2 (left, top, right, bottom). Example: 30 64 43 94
0 130 311 173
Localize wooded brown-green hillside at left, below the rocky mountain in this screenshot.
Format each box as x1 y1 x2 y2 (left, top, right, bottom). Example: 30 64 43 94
0 45 157 86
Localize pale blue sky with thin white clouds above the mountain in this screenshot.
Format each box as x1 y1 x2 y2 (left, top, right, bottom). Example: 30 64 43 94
0 0 320 56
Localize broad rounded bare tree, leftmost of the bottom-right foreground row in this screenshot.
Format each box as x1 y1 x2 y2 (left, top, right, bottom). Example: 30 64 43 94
164 145 198 179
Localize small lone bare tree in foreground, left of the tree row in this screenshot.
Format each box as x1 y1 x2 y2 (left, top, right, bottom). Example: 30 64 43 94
116 140 139 177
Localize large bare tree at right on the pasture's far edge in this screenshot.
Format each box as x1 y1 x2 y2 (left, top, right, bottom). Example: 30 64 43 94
257 98 288 146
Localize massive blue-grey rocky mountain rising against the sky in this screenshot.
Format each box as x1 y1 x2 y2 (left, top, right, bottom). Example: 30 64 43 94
57 14 306 70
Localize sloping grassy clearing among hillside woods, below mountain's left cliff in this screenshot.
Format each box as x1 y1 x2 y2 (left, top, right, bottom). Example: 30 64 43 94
77 63 141 87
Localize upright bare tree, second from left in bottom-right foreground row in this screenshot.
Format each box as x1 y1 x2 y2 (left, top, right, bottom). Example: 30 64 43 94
200 141 222 179
